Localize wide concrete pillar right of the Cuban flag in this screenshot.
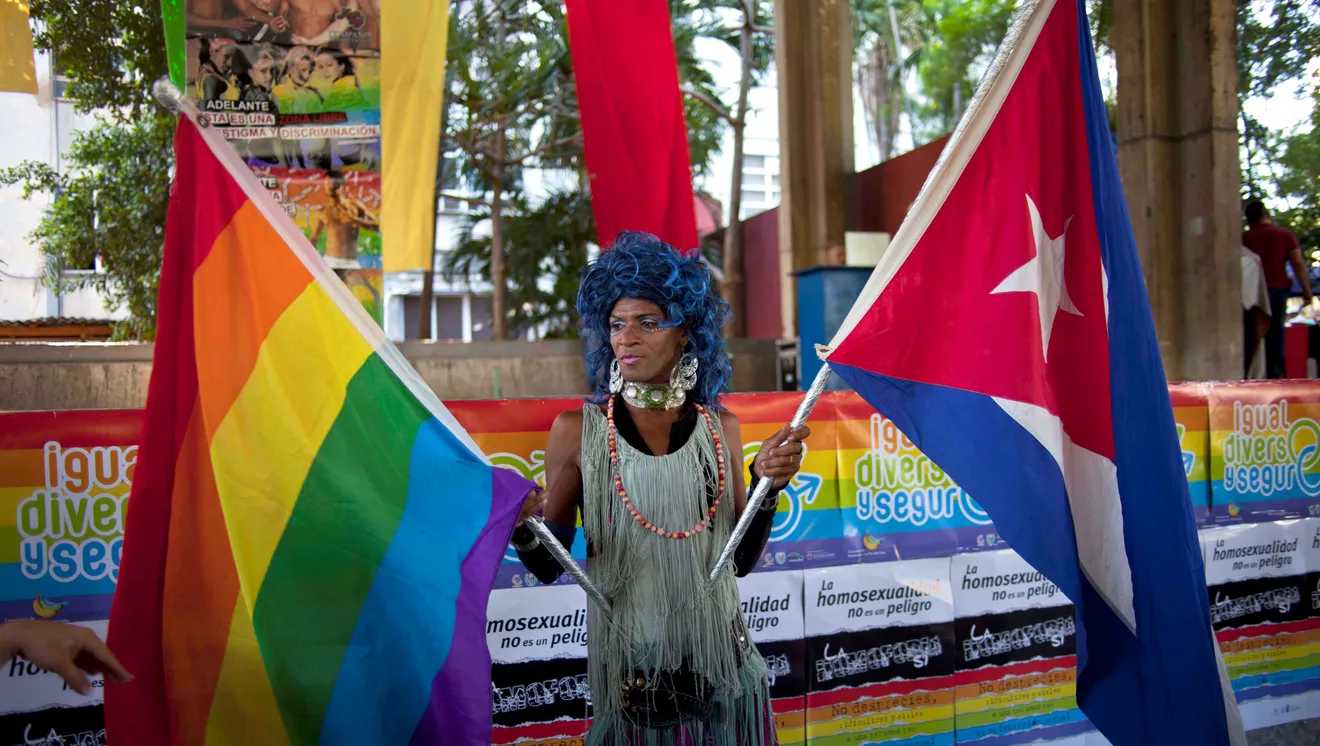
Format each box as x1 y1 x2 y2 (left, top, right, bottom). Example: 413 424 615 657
1111 0 1243 380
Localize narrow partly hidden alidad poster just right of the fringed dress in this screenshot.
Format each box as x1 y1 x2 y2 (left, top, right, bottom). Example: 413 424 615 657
738 570 807 746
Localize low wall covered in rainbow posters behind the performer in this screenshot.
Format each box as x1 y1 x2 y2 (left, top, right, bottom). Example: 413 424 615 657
0 383 1320 746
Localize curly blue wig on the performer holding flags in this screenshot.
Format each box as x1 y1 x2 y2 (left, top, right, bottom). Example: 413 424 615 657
577 231 734 408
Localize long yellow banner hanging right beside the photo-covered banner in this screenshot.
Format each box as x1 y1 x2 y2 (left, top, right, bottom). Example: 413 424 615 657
380 0 449 272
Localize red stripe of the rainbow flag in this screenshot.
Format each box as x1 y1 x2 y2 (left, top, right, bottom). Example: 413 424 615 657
106 118 247 746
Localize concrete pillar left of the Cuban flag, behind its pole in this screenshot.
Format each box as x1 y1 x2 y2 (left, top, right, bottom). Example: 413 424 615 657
775 0 855 338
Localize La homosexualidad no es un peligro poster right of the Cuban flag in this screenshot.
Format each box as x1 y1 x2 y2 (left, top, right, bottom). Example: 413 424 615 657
1203 520 1320 730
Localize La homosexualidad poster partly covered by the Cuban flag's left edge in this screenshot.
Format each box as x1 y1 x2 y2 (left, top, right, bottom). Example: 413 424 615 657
949 549 1102 746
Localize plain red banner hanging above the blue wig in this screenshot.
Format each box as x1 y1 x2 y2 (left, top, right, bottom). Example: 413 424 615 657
566 0 697 251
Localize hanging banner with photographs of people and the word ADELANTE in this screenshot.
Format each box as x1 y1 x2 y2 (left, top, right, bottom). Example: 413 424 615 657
185 0 384 323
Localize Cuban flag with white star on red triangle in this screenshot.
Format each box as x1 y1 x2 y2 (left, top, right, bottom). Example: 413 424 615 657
821 0 1245 746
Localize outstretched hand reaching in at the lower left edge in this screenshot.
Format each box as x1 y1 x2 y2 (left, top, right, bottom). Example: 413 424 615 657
0 619 133 695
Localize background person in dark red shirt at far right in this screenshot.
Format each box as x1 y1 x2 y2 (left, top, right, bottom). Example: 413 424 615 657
1242 199 1312 379
